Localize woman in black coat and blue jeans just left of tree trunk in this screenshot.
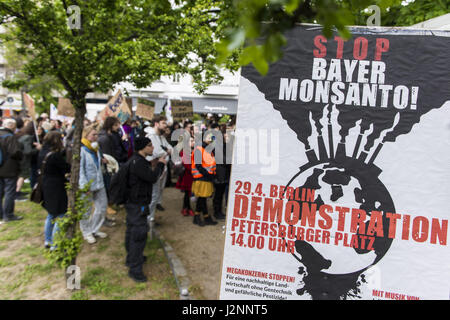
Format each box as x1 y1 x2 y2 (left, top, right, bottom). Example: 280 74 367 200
38 131 70 249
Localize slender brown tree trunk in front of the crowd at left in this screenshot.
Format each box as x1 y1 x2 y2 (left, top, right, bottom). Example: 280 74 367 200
66 95 86 265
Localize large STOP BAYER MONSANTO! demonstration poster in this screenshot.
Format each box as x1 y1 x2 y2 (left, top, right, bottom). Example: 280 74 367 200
219 26 450 300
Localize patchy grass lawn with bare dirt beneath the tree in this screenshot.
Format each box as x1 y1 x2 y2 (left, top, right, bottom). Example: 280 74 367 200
0 194 179 300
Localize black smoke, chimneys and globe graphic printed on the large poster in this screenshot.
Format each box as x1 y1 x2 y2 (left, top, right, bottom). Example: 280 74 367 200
242 27 450 299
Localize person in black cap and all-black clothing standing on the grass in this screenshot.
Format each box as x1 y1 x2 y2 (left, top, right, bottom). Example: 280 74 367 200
125 137 166 282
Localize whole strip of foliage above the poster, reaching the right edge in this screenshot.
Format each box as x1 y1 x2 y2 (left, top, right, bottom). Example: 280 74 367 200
216 0 450 74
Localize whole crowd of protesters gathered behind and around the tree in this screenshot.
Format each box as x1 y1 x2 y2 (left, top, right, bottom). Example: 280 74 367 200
0 113 234 282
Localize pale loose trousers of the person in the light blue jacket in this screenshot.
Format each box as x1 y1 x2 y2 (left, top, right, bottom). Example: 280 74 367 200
80 188 108 237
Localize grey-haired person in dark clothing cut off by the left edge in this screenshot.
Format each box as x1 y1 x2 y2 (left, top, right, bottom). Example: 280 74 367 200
0 119 23 222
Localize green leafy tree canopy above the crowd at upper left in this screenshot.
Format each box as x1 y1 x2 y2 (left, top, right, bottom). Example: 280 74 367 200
0 0 237 99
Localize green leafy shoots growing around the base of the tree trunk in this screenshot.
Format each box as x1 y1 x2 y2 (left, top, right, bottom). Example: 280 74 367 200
46 183 92 269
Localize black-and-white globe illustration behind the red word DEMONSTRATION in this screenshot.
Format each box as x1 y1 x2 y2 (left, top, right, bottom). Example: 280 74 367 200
287 158 395 299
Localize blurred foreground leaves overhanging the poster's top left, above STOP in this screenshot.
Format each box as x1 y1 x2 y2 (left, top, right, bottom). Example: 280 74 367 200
217 0 386 74
